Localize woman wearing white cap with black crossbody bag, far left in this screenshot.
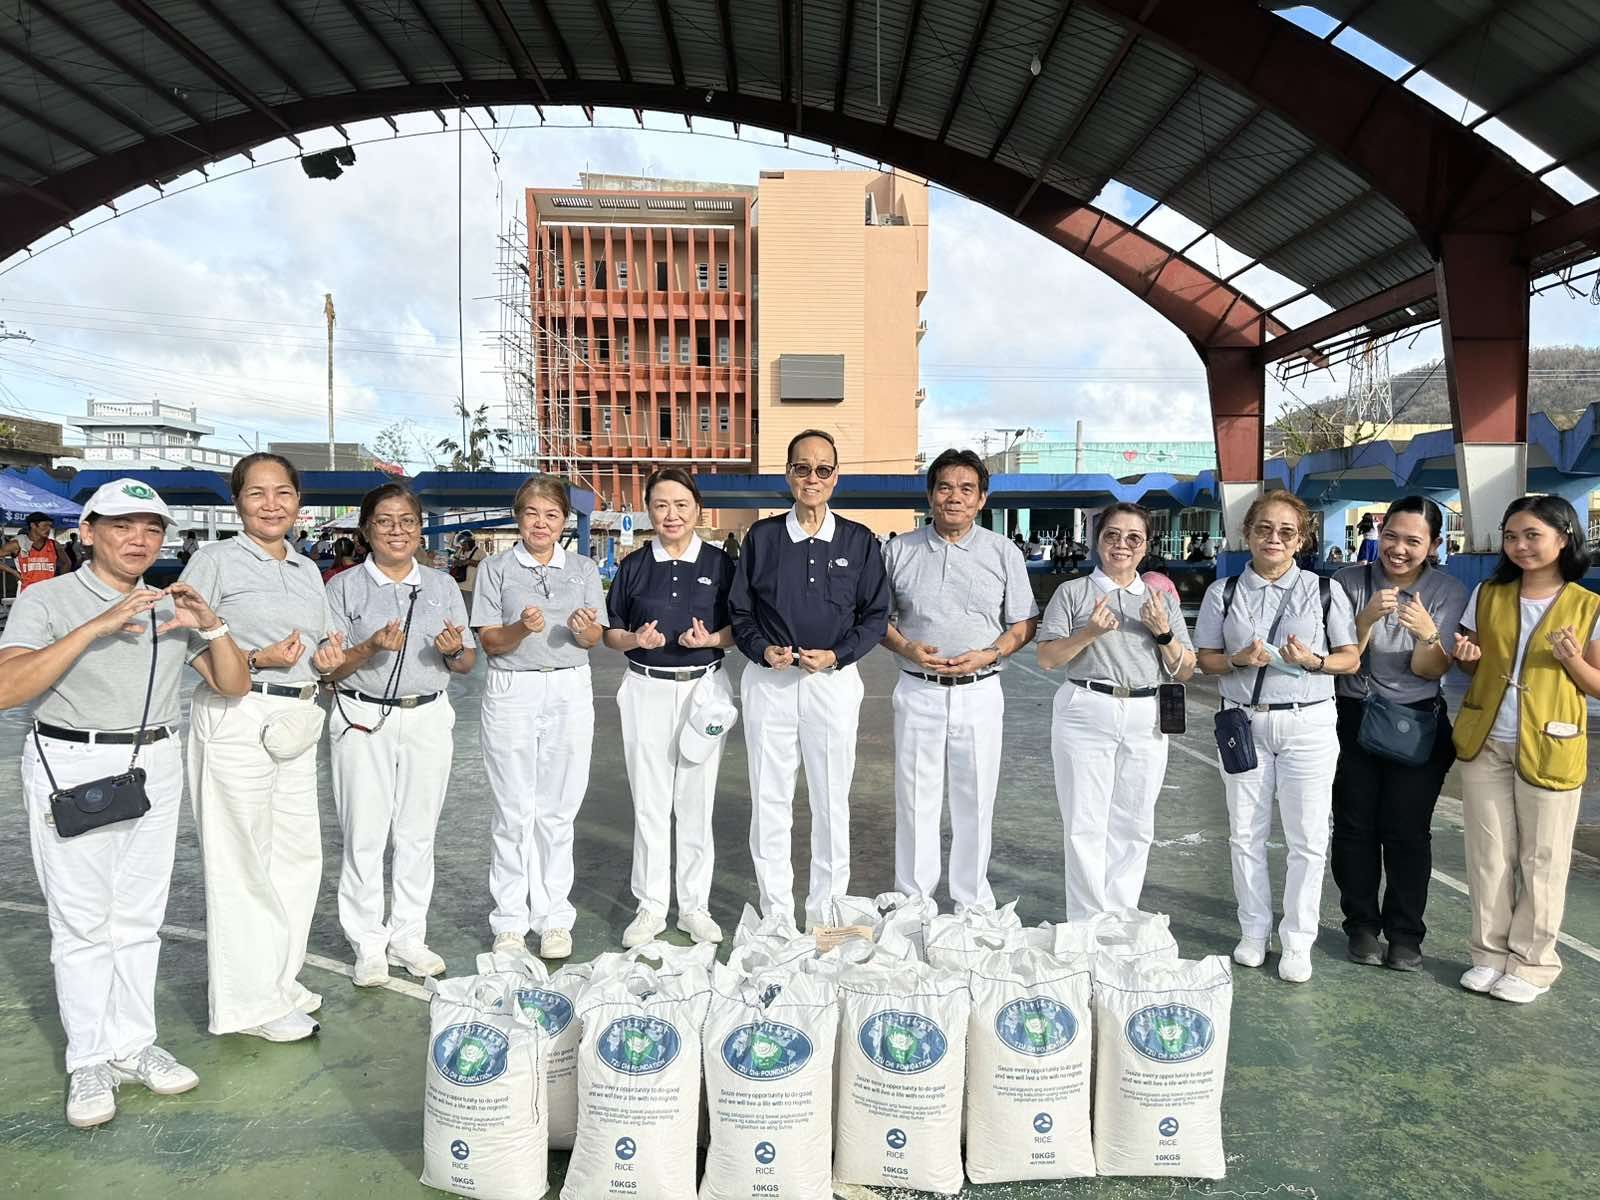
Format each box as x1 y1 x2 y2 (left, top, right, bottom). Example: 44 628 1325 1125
0 478 250 1128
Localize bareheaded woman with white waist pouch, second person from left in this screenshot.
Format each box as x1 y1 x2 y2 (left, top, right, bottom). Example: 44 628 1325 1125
181 453 344 1042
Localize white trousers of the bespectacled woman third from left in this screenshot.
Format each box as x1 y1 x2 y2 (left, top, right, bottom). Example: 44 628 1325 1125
328 696 456 958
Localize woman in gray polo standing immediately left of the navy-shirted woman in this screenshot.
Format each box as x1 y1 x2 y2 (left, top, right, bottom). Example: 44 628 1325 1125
472 475 605 958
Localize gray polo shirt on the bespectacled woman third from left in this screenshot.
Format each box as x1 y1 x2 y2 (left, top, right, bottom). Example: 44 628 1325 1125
328 558 477 696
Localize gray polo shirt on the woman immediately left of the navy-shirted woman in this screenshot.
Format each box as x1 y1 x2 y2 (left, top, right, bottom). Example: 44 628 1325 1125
472 542 606 670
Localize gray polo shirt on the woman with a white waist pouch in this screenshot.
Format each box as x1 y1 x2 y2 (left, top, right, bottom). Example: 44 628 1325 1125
179 534 338 683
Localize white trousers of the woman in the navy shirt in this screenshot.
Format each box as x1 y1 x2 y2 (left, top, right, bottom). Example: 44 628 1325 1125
616 669 733 917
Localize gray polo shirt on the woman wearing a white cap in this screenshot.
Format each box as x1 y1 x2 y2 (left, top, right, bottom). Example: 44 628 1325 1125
0 566 191 731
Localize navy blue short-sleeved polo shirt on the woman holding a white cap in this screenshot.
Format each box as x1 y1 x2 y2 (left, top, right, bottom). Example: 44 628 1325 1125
606 536 733 667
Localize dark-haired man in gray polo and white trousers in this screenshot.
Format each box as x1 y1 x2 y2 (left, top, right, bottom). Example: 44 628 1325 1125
882 450 1038 909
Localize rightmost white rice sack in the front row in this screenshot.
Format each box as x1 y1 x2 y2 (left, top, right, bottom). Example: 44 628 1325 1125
1094 955 1234 1179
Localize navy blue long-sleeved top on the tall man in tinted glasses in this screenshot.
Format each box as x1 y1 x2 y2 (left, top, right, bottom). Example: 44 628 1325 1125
728 509 890 667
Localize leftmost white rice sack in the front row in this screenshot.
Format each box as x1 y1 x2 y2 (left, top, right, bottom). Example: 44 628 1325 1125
422 973 547 1200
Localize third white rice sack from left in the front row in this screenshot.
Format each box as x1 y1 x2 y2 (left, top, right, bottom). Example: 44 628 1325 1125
699 966 838 1200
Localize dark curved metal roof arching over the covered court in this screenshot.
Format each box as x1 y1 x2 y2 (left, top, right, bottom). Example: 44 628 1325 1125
0 0 1600 357
